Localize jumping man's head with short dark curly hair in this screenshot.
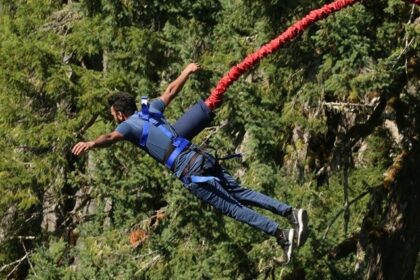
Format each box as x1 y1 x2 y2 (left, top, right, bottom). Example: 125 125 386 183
108 91 137 123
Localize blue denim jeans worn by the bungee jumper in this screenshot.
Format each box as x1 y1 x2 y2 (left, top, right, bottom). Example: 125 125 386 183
180 154 291 235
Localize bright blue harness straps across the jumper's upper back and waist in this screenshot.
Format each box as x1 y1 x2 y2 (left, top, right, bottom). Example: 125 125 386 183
139 96 190 169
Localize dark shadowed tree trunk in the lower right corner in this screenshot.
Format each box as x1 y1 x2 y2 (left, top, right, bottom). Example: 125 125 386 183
359 142 420 279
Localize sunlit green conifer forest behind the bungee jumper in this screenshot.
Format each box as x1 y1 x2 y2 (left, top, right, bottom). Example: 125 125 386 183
0 0 420 279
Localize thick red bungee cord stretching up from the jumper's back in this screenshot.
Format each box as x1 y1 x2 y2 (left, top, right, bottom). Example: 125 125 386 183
205 0 360 110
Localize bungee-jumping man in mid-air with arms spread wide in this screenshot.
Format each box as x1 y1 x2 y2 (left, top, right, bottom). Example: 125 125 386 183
72 63 307 263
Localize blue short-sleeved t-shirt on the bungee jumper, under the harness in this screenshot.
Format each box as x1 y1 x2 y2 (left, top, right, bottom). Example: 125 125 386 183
115 98 195 177
